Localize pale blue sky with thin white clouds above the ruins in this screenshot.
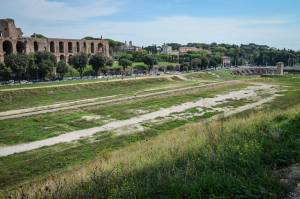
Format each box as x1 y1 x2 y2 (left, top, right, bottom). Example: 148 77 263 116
0 0 300 50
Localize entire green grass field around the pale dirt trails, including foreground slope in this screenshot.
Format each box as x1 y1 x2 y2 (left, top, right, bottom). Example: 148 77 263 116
0 71 300 198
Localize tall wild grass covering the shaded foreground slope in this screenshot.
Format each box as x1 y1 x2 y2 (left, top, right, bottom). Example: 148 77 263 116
2 102 300 198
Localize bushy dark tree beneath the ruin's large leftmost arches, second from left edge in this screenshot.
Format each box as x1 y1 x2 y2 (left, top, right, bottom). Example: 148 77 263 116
4 54 29 81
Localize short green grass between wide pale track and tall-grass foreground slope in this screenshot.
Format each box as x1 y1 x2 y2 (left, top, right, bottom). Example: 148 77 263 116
0 117 200 190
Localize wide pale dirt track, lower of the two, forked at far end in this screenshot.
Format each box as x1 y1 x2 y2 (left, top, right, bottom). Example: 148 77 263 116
0 84 275 157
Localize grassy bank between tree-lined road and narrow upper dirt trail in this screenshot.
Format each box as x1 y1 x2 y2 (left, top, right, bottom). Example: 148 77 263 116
0 77 182 111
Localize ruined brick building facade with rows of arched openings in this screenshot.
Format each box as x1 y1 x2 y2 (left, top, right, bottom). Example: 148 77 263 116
0 19 109 63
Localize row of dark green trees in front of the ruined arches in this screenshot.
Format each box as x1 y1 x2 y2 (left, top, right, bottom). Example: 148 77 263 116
0 52 157 81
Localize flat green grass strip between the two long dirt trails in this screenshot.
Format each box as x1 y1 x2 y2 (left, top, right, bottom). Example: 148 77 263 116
0 83 248 145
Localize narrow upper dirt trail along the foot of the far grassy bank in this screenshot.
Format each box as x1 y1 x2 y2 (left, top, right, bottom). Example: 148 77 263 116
0 80 242 120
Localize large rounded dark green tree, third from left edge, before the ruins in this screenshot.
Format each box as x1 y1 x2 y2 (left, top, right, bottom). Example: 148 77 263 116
34 51 56 79
